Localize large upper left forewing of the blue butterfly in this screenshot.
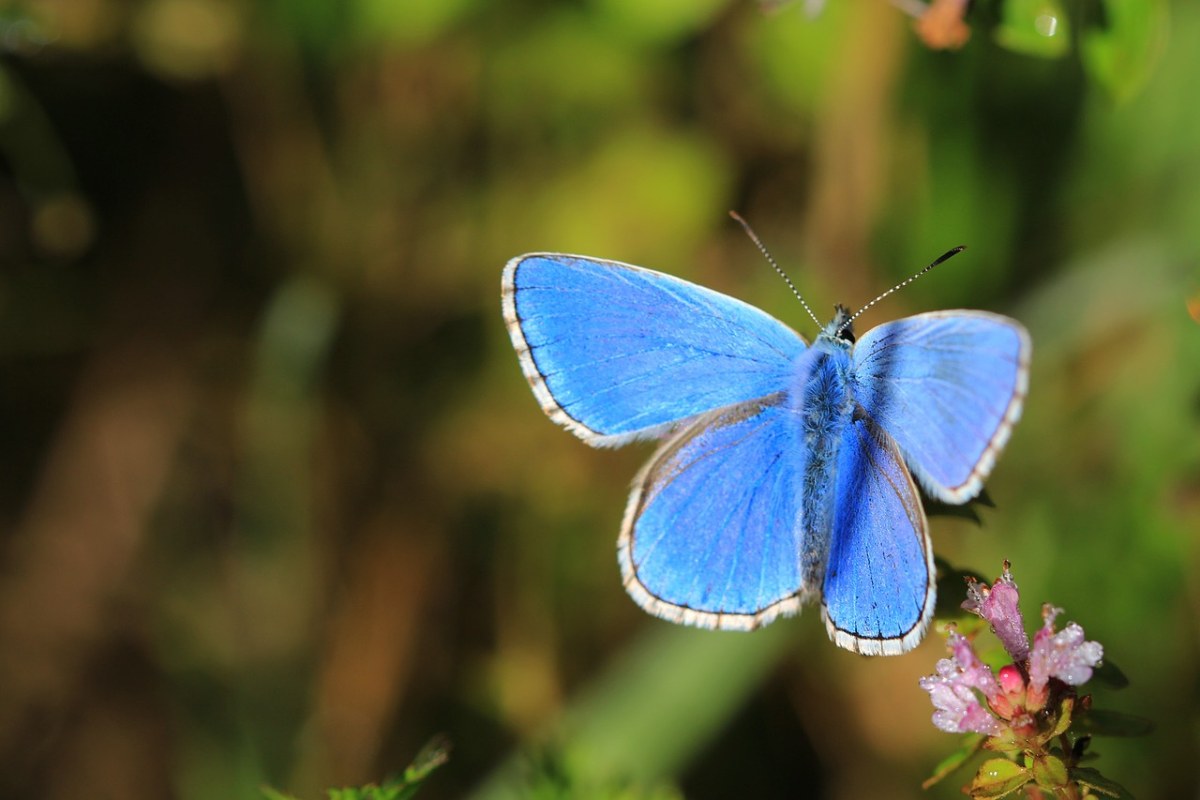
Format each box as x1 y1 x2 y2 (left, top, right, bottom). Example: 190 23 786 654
503 253 805 445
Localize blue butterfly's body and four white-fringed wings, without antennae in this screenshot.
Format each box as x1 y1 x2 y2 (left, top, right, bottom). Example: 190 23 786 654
503 253 1031 655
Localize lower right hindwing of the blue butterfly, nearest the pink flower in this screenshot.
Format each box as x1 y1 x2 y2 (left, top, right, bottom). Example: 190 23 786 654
821 409 936 655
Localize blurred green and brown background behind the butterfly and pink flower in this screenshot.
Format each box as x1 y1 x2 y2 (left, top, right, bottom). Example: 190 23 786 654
0 0 1200 800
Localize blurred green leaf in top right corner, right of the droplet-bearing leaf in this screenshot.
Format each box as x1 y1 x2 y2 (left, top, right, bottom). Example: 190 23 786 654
1080 0 1168 102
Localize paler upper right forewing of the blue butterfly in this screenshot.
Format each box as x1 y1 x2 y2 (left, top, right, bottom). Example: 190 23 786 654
853 311 1030 504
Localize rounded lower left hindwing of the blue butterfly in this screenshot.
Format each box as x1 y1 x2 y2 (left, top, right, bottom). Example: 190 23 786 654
617 393 805 630
